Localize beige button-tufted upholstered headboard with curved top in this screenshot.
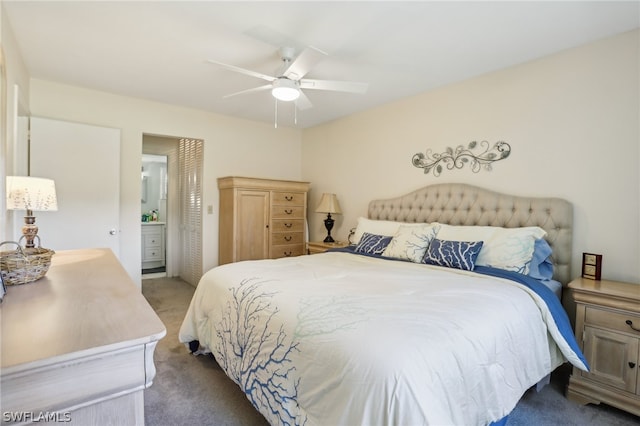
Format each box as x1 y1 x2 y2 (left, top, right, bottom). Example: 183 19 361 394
368 183 573 285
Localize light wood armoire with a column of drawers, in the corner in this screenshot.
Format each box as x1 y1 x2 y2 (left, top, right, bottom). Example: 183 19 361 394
218 176 309 265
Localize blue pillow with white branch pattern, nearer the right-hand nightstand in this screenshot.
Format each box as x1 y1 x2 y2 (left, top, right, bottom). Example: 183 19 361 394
423 238 483 271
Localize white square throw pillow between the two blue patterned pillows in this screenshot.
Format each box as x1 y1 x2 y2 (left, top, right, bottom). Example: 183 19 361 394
382 224 440 263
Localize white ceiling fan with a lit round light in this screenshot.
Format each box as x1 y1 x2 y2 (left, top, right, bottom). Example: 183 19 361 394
208 46 369 110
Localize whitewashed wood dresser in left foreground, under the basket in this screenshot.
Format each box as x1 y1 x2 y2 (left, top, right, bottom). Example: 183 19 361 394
0 249 166 426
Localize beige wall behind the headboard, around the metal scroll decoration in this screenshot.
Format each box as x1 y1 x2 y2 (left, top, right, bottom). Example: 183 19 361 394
302 31 640 282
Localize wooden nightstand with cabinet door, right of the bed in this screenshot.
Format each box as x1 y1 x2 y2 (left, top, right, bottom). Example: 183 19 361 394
567 278 640 416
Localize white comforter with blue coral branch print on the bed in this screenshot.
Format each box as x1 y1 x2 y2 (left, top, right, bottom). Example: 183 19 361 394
180 252 584 426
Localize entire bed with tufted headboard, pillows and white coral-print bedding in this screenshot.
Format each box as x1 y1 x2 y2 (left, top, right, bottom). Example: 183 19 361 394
179 184 588 425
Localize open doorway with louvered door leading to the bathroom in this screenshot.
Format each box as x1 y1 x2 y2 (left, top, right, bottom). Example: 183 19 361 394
141 135 204 287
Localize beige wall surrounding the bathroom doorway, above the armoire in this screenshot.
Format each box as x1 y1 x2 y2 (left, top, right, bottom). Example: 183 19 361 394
30 79 301 282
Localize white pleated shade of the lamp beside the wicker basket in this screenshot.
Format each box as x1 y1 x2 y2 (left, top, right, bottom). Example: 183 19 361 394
7 176 58 211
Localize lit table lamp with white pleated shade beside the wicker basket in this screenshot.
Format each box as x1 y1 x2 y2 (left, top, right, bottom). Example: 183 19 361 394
7 176 58 248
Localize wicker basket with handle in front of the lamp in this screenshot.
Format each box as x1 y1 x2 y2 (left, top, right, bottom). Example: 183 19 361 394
0 239 55 285
